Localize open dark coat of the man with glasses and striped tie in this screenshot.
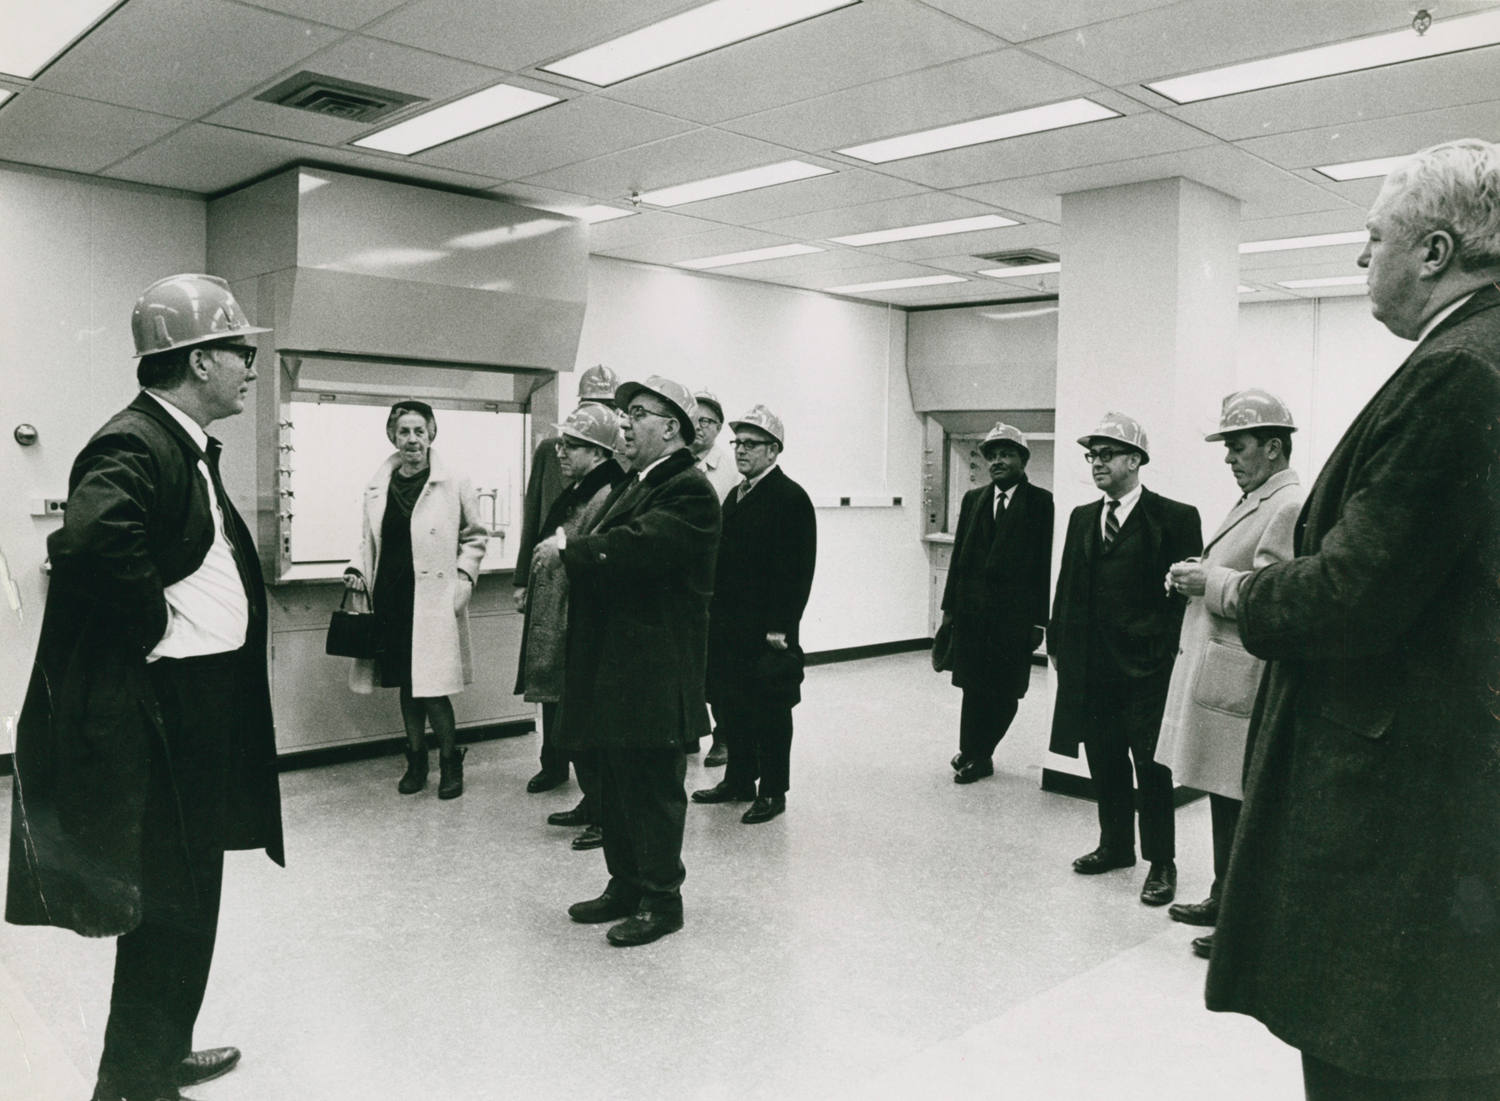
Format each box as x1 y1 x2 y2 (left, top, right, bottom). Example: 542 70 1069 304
1047 488 1203 758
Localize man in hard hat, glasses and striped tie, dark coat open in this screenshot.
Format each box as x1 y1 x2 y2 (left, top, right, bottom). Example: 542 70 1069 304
1047 413 1203 906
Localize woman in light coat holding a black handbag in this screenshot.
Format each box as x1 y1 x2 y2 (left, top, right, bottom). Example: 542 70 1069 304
344 401 488 800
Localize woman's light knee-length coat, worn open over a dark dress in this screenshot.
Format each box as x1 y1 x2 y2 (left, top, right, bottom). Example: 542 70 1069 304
350 447 488 698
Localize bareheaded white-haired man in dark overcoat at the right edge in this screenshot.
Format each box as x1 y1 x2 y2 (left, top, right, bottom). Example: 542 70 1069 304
1208 141 1500 1101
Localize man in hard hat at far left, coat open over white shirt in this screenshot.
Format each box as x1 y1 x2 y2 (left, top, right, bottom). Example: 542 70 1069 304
6 275 284 1101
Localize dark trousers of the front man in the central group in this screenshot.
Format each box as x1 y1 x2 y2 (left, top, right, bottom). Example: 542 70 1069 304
597 747 687 914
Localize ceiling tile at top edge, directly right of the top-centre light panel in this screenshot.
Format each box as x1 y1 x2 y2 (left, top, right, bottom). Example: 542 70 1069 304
605 0 1002 123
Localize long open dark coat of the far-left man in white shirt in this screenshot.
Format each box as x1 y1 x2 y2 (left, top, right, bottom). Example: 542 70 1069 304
6 393 284 936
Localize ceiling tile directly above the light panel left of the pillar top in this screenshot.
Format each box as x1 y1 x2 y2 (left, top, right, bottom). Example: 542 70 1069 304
723 50 1098 150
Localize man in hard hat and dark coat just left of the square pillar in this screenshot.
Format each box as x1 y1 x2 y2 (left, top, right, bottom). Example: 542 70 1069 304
942 422 1053 783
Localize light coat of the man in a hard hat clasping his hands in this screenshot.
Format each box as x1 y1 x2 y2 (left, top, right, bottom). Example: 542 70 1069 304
1157 470 1302 800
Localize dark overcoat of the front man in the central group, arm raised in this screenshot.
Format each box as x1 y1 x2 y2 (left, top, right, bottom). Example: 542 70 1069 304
558 447 720 750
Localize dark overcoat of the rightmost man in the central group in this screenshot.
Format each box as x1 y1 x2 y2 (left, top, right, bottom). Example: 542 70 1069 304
708 467 818 707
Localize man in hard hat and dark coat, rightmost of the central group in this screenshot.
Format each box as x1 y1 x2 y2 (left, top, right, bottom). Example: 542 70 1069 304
693 405 818 825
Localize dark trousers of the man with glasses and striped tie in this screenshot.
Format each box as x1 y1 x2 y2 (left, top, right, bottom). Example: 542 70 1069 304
1083 671 1176 864
